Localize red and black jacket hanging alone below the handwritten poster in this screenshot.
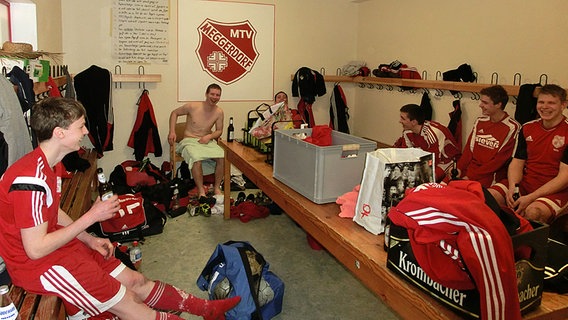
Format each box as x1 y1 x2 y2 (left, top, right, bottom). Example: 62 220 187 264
128 90 162 161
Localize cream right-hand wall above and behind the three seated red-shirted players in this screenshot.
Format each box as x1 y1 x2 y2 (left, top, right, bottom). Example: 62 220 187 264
354 0 568 143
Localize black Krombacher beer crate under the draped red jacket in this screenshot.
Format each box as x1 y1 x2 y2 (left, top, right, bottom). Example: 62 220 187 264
387 223 549 319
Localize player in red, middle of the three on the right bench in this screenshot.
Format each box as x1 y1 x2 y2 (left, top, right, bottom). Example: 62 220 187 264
457 85 521 188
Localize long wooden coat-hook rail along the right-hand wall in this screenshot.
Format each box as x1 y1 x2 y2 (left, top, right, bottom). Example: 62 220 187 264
291 75 519 96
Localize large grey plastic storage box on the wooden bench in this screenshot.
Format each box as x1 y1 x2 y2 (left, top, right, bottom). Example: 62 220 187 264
273 129 377 204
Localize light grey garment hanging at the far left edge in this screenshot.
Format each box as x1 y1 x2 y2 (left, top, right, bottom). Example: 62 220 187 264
0 77 33 166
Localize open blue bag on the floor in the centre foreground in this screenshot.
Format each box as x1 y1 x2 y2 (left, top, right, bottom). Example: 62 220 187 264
197 241 284 320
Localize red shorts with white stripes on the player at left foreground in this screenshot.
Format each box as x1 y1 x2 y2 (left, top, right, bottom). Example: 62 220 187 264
17 240 126 319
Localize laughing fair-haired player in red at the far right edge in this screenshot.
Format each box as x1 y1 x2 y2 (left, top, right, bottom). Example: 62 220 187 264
489 84 568 223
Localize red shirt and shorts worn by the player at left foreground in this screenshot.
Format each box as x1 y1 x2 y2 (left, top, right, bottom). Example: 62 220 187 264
0 148 126 316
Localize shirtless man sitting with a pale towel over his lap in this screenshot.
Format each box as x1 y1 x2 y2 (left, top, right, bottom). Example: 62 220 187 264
168 83 224 197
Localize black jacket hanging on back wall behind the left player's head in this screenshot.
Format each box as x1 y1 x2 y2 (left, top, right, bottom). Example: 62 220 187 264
74 65 114 157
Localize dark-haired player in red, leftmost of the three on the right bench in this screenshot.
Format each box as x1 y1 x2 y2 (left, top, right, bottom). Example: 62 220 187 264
394 104 461 182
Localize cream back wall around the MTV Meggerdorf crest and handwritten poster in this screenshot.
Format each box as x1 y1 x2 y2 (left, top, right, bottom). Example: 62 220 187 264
60 0 357 172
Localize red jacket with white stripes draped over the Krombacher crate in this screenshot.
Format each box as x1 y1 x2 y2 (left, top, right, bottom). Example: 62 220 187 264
389 180 521 319
